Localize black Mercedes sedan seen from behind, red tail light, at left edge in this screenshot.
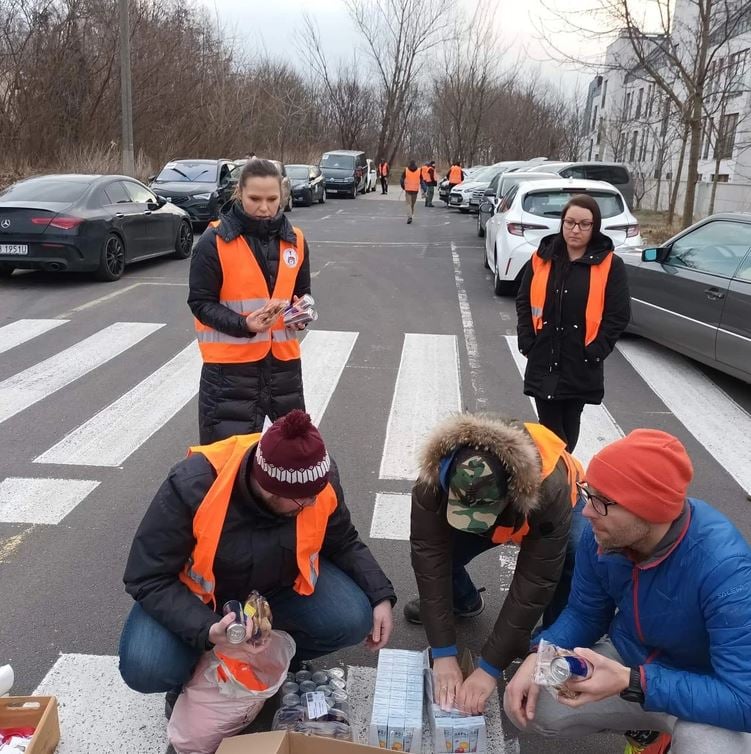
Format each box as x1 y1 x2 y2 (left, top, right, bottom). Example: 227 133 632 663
0 175 193 280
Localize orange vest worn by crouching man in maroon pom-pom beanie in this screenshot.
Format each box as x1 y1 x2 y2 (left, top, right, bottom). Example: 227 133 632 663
180 433 337 610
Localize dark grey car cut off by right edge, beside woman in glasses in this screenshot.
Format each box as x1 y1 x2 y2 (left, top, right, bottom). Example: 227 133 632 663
619 213 751 383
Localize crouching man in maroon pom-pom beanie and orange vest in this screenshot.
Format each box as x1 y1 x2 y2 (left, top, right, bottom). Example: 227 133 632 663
119 410 396 714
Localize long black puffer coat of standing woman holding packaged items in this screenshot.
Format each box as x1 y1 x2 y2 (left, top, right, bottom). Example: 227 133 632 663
188 202 310 444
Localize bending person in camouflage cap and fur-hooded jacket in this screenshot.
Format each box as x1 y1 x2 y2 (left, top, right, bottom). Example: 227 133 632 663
404 414 584 712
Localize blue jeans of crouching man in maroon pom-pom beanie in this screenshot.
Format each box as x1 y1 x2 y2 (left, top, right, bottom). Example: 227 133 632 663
120 558 373 694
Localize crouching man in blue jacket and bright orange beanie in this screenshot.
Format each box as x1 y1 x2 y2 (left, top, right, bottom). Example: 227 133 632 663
504 429 751 754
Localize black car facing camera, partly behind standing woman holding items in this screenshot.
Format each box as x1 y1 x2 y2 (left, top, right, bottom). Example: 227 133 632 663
149 160 239 224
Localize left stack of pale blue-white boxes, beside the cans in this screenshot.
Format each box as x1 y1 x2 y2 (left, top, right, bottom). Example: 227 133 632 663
368 649 423 752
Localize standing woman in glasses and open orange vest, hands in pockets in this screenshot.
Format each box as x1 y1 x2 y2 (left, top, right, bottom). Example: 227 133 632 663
516 195 631 453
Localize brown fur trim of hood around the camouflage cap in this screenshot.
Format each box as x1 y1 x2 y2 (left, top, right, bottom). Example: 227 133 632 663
418 414 542 516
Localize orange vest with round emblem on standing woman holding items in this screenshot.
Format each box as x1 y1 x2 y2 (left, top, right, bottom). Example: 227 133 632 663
193 222 305 364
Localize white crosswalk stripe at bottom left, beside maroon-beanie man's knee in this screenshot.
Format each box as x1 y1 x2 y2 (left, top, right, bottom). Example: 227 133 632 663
34 654 167 754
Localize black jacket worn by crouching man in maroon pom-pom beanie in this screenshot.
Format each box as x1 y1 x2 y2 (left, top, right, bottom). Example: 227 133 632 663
123 448 396 649
